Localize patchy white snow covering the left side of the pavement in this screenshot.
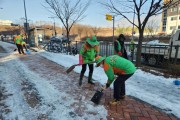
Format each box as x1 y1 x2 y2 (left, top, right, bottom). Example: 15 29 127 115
0 42 107 120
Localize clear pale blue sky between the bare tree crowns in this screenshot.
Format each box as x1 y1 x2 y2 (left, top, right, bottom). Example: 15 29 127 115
0 0 160 27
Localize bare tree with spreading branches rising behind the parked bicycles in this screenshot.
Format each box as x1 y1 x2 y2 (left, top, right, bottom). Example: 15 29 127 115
45 0 90 39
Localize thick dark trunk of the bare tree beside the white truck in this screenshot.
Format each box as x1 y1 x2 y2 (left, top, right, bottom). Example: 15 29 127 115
136 30 144 67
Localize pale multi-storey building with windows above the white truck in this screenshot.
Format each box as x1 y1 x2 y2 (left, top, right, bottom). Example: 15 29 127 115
161 0 180 34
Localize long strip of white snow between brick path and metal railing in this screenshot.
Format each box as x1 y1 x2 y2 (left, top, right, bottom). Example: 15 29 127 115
0 43 180 117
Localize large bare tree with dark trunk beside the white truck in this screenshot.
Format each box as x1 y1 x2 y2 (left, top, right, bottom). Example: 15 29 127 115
101 0 179 67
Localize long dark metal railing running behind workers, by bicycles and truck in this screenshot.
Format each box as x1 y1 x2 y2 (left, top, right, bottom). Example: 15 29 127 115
4 39 180 66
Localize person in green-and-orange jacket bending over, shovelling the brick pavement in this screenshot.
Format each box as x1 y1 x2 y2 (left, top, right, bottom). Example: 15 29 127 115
95 55 136 105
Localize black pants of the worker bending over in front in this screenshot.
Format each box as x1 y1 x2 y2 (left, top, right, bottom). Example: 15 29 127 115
114 73 134 100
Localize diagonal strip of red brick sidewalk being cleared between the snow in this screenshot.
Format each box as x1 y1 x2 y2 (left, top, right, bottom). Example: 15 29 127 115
21 53 178 120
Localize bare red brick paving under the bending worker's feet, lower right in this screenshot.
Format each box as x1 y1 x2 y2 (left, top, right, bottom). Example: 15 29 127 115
103 90 178 120
